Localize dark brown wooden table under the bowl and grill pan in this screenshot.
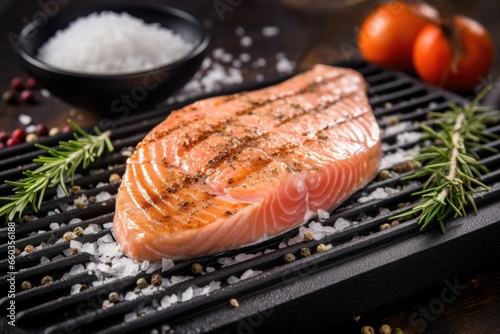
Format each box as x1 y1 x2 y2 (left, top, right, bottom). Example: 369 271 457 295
0 0 500 334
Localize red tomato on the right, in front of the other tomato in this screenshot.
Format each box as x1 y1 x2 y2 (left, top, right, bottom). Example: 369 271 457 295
413 16 494 92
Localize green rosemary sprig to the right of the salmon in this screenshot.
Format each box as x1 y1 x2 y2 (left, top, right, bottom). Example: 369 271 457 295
391 90 500 233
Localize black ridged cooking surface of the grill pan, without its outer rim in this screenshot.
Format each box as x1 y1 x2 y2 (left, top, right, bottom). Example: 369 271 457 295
0 64 500 333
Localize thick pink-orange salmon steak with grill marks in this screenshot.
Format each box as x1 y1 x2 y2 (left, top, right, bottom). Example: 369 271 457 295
113 65 381 261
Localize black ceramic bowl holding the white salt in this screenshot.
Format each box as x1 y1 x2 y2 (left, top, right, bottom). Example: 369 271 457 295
17 5 209 113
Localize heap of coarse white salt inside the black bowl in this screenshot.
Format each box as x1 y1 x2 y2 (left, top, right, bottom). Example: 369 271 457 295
38 11 193 74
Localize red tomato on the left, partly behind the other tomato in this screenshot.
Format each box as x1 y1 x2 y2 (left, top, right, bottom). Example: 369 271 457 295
358 1 437 72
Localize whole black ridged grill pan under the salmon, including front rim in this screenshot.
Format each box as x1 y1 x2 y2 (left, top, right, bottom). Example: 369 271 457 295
0 61 500 333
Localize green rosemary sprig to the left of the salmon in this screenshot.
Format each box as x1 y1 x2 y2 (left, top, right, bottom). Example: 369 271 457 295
0 120 114 221
